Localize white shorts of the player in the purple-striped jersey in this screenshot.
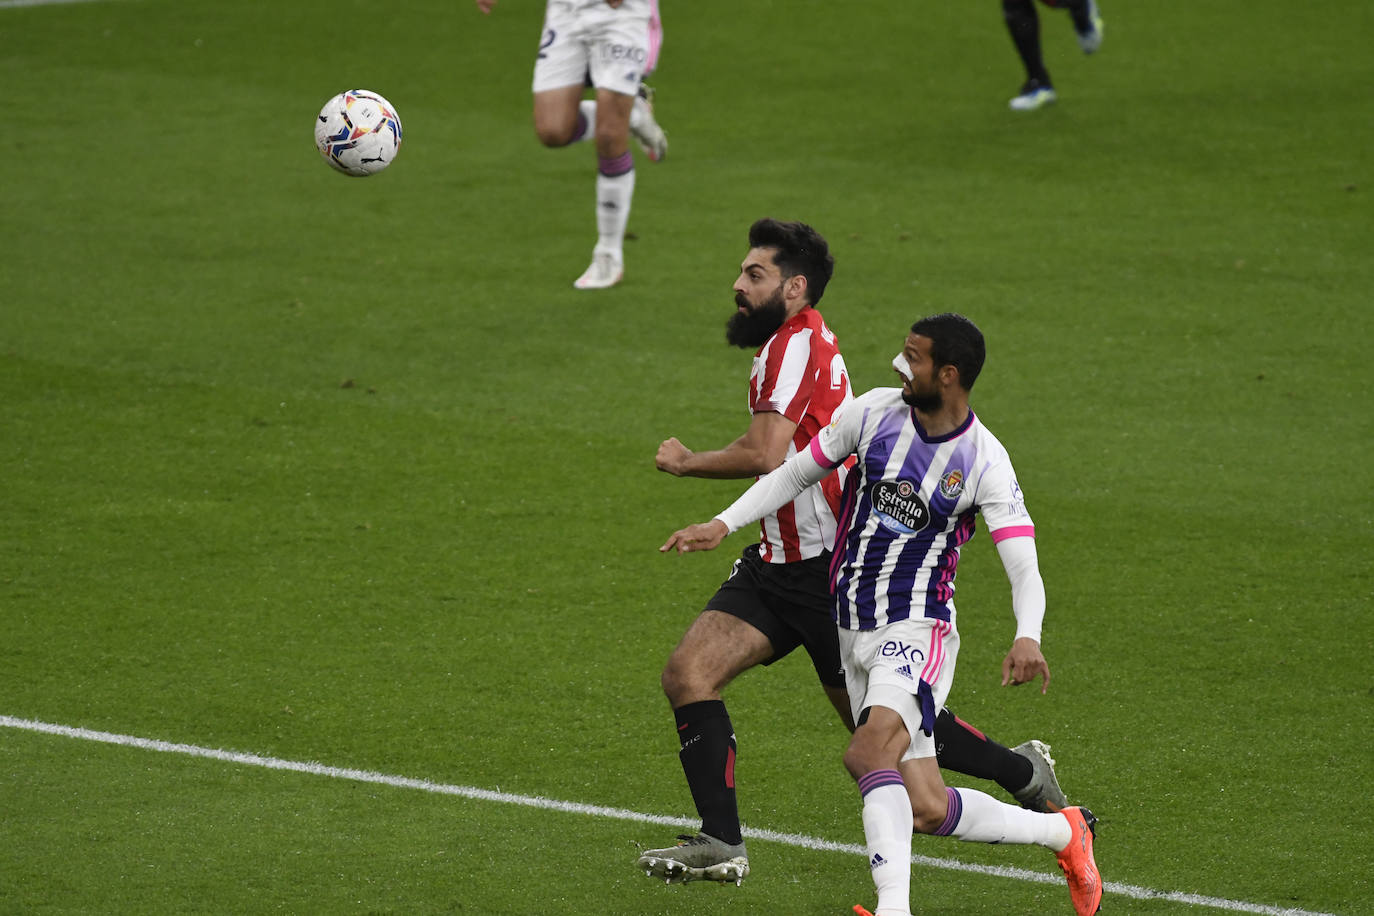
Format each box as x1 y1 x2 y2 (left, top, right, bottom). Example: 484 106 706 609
840 618 959 761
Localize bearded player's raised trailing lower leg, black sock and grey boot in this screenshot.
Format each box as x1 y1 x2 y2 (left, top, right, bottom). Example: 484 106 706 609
934 709 1069 812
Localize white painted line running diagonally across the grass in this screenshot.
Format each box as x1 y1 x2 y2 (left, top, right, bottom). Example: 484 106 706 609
0 715 1336 916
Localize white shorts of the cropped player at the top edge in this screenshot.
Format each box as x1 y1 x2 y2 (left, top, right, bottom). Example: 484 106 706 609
534 0 657 96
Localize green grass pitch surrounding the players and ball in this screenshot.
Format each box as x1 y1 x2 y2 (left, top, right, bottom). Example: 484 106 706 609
0 0 1374 916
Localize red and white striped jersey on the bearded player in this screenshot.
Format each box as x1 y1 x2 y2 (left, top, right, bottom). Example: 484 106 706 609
749 306 853 563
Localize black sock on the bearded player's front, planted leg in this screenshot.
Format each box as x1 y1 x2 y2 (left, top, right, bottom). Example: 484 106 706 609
673 700 742 845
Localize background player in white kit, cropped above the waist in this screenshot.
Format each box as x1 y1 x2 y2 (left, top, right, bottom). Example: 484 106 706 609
477 0 668 290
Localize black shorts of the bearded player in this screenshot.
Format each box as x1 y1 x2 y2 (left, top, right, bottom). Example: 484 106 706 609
706 544 845 687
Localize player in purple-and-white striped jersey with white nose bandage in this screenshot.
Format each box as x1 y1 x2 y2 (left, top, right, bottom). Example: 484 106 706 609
661 314 1102 916
